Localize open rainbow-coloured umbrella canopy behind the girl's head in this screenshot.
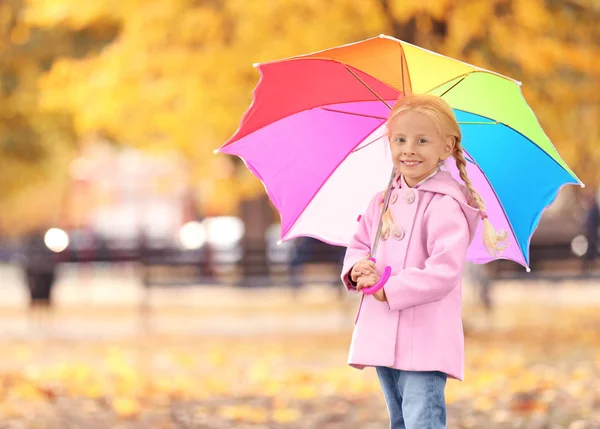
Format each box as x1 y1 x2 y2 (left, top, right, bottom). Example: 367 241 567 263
218 35 583 268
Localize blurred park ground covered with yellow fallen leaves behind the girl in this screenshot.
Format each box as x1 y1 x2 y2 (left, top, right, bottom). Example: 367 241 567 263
0 264 600 429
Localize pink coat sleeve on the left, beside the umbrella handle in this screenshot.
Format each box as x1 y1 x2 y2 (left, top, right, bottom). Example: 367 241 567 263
342 195 379 291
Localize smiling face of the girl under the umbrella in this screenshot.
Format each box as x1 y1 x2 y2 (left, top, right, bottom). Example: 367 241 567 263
388 111 454 187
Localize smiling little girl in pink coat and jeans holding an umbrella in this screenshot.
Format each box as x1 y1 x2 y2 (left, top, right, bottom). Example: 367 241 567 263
342 95 506 429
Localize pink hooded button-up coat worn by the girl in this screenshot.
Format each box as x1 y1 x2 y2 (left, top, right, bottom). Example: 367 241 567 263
342 171 480 380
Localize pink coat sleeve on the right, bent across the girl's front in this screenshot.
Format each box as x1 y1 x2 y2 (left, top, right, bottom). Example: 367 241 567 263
384 195 470 310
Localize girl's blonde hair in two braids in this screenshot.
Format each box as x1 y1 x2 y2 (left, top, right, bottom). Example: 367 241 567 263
381 94 507 256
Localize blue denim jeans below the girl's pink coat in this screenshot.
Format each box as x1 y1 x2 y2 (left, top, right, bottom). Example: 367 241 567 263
376 366 447 429
